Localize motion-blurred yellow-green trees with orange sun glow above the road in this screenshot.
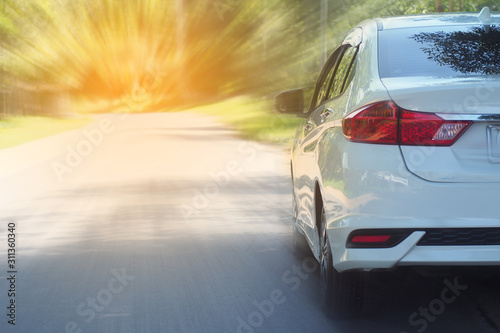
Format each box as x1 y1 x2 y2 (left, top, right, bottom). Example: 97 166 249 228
0 0 500 111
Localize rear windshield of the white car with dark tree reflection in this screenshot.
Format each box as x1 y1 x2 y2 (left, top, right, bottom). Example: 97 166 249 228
379 25 500 78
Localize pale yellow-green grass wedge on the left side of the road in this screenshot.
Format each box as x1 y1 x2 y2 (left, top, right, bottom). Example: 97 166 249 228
0 116 92 149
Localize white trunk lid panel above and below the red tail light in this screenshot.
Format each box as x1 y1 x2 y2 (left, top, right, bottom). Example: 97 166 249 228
382 75 500 183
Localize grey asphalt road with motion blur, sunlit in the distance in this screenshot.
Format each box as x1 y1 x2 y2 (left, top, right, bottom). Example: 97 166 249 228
0 113 500 333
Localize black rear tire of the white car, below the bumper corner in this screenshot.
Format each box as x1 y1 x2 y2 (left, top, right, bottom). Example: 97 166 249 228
320 209 365 318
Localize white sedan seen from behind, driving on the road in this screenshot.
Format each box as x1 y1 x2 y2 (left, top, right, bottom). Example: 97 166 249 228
276 8 500 315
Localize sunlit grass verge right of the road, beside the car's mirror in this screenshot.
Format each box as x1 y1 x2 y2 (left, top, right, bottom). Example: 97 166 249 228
192 97 303 147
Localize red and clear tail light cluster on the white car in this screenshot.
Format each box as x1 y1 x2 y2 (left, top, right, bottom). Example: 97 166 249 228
342 101 471 146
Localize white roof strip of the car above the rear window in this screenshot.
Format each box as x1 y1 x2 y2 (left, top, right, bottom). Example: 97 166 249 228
376 13 500 30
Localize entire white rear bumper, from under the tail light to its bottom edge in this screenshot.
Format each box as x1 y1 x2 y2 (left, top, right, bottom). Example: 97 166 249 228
319 140 500 271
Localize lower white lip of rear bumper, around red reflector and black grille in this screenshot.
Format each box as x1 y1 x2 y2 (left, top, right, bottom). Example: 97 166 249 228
327 216 500 272
